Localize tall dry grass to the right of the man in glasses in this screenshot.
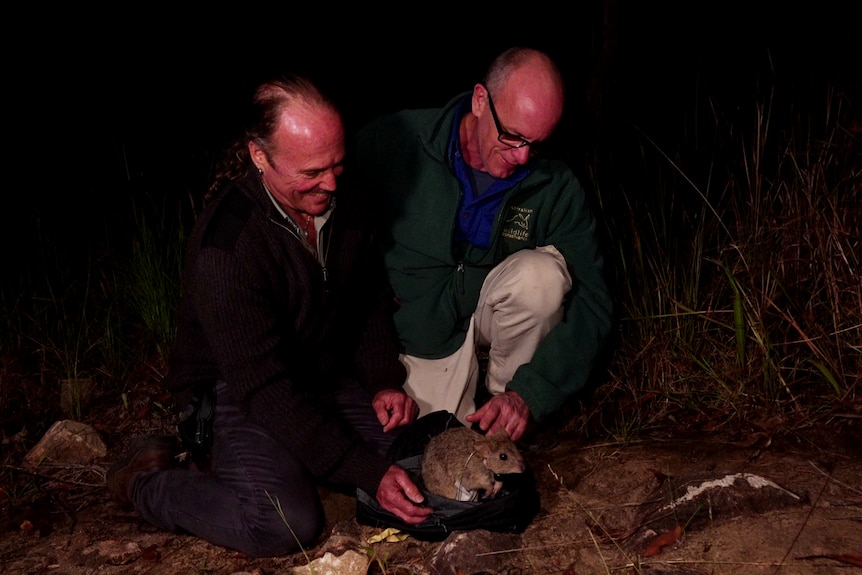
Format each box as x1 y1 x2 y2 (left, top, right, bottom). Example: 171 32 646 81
585 82 862 438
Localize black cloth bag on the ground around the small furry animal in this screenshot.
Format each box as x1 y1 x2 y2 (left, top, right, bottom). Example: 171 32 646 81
356 411 540 541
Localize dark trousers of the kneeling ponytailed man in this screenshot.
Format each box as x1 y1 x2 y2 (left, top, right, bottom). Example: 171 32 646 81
132 382 396 557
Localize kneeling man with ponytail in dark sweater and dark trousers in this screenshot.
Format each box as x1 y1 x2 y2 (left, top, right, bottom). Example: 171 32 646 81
106 76 432 557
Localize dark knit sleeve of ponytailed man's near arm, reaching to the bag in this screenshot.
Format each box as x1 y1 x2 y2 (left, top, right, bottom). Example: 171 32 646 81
187 225 389 493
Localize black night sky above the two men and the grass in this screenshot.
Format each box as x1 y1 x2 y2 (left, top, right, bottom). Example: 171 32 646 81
0 5 862 282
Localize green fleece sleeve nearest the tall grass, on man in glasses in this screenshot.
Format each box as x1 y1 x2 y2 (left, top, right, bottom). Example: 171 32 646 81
508 170 612 421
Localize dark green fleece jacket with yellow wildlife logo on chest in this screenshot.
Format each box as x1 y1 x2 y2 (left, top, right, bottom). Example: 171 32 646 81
353 94 611 421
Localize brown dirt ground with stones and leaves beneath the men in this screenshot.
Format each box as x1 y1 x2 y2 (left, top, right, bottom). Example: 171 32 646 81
0 420 862 575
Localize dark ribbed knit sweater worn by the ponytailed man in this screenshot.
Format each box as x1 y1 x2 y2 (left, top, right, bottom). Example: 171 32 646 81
166 172 406 493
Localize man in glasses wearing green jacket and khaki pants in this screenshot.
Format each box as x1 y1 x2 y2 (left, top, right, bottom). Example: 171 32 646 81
355 47 612 441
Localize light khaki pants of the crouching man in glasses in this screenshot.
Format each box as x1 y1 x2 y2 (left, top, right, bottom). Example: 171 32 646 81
401 246 572 426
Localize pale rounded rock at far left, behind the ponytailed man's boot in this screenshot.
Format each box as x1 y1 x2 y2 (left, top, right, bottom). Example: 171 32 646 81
24 419 108 468
